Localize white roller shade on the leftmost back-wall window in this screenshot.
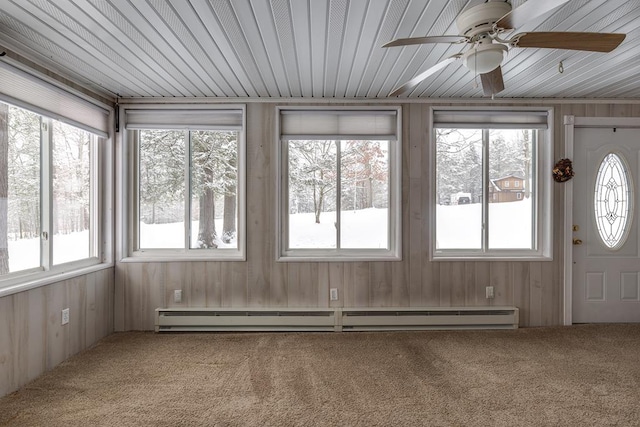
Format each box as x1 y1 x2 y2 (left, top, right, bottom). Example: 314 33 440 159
124 108 243 131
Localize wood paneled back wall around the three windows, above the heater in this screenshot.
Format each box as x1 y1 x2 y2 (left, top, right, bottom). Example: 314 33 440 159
115 102 640 330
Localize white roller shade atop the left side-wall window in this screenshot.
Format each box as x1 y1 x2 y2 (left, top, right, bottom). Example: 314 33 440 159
0 62 109 138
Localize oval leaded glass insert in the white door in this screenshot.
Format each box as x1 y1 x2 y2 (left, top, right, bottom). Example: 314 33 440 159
594 153 632 249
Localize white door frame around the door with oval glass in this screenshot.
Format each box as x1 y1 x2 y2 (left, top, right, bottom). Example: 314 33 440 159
562 115 640 325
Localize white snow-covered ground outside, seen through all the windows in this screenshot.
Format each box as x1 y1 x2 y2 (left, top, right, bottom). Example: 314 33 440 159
9 203 532 272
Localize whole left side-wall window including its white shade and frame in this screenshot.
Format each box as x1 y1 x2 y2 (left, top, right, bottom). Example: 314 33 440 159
0 62 112 296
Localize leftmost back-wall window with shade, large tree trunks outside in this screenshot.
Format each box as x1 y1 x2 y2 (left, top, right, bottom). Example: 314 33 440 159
124 105 244 260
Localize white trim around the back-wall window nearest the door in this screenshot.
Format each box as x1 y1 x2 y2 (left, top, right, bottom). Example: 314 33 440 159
429 107 554 261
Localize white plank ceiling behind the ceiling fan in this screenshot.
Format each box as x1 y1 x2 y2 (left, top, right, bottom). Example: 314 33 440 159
0 0 640 99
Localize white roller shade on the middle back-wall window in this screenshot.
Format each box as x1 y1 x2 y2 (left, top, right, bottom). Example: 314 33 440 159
280 110 398 140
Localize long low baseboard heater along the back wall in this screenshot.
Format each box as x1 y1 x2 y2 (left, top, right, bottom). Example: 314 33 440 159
155 307 519 332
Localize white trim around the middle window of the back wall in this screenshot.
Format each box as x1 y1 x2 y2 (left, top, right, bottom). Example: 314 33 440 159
273 106 402 262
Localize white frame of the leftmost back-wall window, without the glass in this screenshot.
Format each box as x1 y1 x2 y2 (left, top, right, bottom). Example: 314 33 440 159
116 102 247 262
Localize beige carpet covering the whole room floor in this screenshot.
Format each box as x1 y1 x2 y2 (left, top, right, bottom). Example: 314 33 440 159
0 325 640 426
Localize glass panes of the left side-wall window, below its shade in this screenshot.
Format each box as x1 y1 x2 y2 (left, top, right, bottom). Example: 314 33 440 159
0 102 99 280
